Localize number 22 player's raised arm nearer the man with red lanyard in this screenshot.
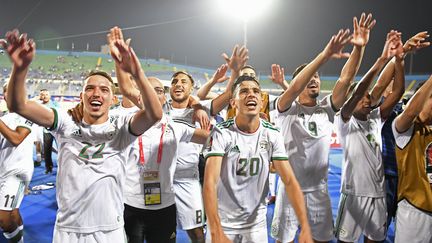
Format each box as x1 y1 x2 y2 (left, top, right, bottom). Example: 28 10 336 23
113 30 163 135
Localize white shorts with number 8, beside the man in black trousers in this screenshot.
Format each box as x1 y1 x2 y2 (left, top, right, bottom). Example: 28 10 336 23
174 180 204 230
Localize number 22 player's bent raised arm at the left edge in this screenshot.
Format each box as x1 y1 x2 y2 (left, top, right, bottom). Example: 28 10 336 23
0 30 54 127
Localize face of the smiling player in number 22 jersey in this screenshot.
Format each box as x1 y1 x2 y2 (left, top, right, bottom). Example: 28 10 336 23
81 75 114 121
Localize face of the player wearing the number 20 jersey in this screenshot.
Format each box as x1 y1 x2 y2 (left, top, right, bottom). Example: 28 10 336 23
233 81 262 116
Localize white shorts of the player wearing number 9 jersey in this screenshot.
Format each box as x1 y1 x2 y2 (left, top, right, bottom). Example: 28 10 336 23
271 186 333 242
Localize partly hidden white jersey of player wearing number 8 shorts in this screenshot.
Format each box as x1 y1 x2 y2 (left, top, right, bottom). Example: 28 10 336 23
167 100 212 180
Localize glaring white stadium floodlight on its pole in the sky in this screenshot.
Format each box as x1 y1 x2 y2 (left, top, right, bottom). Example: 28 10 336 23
216 0 272 46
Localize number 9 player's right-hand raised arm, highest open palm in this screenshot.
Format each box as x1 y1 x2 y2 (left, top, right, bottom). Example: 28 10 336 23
331 13 376 109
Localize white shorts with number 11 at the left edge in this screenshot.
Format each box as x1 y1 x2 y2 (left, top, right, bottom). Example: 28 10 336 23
0 175 27 211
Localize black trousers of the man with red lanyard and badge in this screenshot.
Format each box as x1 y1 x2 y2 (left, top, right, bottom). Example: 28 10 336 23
124 204 177 243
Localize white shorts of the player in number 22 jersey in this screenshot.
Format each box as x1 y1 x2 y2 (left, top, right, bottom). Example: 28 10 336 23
52 227 127 243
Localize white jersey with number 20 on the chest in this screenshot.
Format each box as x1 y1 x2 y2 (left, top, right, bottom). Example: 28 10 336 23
206 118 287 234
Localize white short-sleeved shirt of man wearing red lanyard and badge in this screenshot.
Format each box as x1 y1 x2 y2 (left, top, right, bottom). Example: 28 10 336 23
124 115 195 210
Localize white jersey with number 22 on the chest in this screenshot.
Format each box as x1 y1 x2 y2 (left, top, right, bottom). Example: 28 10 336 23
52 109 136 233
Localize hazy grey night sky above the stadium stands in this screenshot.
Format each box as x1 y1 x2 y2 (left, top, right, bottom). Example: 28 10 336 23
0 0 432 75
